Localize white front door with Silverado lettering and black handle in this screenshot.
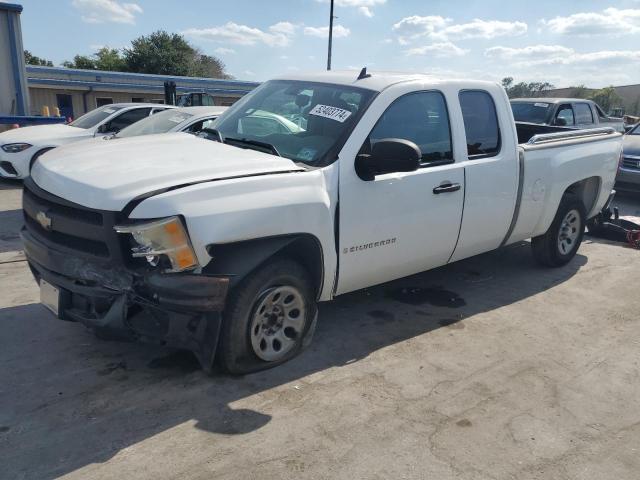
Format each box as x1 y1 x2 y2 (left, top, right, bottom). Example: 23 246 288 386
336 90 465 294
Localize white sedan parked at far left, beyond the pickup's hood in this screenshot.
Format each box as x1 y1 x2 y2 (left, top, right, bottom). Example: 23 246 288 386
0 103 175 178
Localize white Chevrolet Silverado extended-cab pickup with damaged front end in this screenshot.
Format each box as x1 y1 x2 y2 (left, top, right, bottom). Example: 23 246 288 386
22 70 622 374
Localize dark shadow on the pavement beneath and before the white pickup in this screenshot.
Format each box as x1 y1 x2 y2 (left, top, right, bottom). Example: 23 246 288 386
0 243 587 479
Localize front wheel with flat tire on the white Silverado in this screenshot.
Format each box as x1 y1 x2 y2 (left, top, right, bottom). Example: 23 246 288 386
218 258 317 375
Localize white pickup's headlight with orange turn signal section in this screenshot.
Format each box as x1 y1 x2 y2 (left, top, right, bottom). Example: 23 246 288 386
113 217 198 272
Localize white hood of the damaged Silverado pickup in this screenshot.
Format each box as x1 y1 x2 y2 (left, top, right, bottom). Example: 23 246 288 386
31 133 304 211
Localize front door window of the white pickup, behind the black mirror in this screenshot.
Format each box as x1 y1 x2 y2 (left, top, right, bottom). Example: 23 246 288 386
369 92 453 165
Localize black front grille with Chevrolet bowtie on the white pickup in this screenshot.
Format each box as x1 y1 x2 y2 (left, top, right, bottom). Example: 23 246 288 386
22 178 122 260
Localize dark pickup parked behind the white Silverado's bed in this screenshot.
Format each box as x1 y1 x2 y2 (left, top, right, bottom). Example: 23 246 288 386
511 98 624 133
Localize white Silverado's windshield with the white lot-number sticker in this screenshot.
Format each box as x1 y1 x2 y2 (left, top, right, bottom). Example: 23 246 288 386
216 80 375 166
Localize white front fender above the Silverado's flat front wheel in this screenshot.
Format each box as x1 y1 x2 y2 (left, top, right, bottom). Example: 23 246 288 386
130 168 337 300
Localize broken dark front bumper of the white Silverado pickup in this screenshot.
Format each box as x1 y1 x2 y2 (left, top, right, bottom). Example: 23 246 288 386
21 229 229 370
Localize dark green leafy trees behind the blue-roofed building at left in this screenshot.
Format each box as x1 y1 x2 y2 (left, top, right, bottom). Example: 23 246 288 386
62 30 231 78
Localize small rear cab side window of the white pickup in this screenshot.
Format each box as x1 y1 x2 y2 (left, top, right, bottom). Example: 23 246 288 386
459 90 500 158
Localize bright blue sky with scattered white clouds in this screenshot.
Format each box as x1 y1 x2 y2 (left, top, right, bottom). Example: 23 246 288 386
13 0 640 87
